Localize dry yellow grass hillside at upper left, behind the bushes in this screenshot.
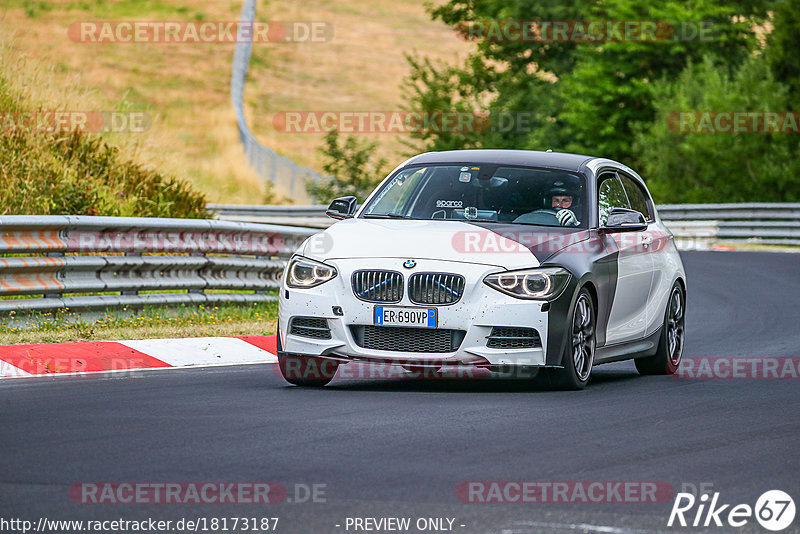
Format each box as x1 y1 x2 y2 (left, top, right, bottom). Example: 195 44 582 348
0 0 470 203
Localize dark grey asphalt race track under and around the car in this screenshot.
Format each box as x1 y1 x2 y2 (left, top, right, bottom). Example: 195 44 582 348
0 252 800 534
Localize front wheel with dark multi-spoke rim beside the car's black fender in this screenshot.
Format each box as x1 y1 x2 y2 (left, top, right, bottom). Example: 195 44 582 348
547 287 597 390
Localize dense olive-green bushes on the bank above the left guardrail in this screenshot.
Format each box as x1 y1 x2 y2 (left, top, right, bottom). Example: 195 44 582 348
0 79 206 218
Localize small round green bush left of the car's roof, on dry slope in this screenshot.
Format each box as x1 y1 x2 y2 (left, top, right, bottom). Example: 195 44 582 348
306 130 388 203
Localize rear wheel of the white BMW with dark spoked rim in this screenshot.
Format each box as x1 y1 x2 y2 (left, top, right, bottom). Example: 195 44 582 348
634 282 686 375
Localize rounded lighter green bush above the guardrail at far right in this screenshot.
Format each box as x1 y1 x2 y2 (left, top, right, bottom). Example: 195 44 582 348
634 55 800 203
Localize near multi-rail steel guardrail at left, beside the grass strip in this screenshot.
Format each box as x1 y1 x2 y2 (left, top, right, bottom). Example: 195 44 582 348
0 215 315 311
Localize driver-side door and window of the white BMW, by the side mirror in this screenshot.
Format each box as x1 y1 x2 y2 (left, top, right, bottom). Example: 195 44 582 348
597 172 653 345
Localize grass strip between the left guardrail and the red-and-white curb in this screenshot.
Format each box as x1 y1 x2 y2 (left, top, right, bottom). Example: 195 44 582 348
0 302 278 345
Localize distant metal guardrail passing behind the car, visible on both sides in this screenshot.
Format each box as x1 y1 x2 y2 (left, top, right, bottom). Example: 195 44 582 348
208 203 800 250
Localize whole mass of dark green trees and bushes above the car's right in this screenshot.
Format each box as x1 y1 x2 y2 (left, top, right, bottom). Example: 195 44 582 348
406 0 800 202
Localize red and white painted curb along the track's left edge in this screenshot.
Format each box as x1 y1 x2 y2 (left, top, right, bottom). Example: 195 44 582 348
0 335 277 378
